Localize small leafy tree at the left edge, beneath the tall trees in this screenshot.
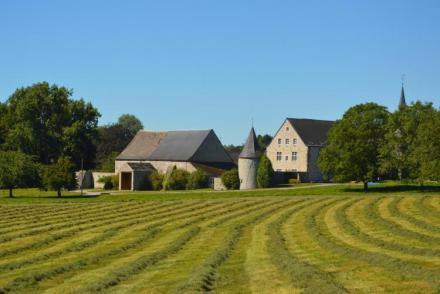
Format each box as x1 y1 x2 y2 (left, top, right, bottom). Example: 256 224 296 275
0 151 39 197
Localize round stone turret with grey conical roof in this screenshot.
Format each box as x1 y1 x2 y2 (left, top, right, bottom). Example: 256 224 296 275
238 128 258 190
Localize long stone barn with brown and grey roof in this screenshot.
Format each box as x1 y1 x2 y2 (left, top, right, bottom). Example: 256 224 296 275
115 130 236 190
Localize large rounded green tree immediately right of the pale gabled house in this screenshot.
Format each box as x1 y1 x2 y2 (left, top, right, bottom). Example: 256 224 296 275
318 103 389 191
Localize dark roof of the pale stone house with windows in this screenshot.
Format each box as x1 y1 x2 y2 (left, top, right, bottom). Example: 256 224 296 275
287 118 334 146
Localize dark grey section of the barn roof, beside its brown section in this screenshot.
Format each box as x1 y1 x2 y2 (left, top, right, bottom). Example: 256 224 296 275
148 130 211 161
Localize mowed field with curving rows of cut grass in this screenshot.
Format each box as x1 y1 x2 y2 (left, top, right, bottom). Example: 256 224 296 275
0 194 440 293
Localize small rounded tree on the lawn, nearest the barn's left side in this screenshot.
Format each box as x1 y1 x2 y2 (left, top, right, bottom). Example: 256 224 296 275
43 157 76 197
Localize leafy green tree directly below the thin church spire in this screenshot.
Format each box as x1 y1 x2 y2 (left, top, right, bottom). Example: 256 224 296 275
379 101 436 180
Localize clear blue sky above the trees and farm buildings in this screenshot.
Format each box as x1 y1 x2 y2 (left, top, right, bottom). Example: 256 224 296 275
0 0 440 144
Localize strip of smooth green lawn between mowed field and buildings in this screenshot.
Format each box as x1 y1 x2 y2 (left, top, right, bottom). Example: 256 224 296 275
0 182 440 204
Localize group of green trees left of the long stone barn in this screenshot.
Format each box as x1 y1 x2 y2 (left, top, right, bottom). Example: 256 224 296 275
0 82 143 196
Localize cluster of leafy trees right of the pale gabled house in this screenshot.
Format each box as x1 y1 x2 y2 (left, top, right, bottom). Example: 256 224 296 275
318 101 440 190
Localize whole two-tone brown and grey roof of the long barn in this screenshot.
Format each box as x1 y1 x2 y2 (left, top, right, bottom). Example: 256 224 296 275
116 130 232 163
